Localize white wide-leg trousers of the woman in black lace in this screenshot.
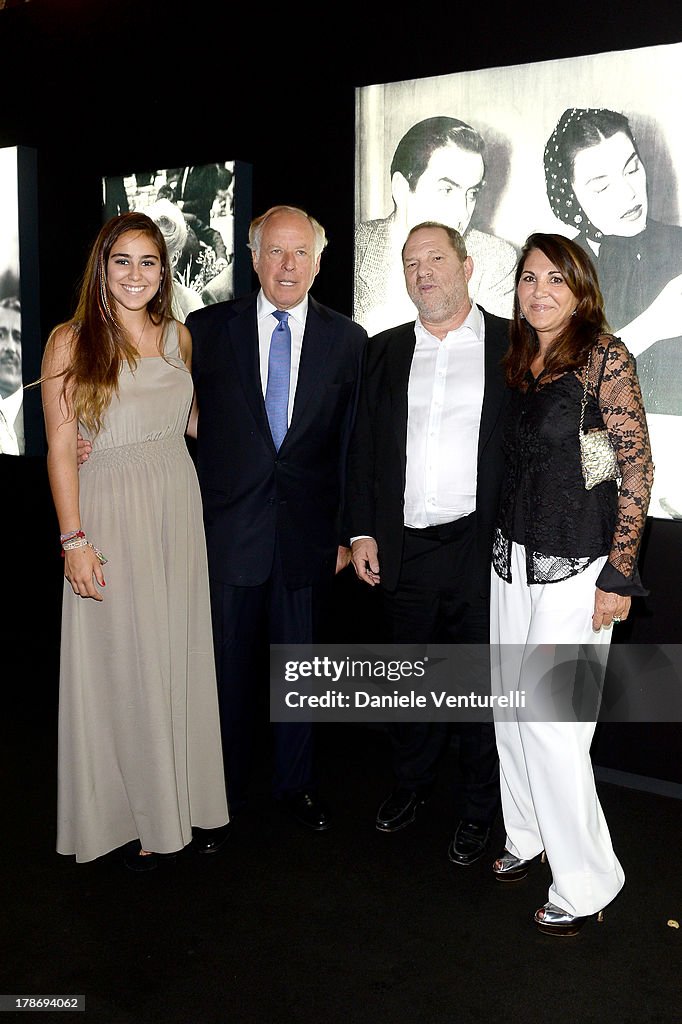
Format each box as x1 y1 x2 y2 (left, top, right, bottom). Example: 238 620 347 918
491 544 625 916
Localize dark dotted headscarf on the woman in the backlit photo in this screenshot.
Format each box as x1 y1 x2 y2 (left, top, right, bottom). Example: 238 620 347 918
545 106 637 242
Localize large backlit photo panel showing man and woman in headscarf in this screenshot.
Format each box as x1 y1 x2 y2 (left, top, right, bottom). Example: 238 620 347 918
353 44 682 518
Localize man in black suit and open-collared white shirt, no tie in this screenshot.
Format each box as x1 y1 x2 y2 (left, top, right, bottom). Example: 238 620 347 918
347 221 508 865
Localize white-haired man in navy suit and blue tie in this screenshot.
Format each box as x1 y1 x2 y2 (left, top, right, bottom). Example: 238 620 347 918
186 206 367 845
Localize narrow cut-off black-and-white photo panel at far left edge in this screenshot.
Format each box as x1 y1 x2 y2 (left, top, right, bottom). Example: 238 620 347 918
0 146 26 455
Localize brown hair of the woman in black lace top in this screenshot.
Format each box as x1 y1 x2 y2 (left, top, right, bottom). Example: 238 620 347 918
503 231 609 387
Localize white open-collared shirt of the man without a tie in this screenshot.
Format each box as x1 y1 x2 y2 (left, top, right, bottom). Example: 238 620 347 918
404 304 484 528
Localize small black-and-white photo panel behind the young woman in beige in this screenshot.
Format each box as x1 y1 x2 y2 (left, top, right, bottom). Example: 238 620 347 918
102 161 235 321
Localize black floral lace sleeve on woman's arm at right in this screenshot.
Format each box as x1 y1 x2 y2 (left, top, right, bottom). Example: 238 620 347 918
590 338 653 593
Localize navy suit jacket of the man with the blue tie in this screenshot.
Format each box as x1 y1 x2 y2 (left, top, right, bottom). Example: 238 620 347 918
186 293 367 588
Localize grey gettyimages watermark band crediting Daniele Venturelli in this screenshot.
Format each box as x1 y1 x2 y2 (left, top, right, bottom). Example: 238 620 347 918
270 644 682 722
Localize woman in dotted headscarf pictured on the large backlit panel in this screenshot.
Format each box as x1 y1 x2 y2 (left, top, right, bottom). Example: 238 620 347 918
545 106 682 416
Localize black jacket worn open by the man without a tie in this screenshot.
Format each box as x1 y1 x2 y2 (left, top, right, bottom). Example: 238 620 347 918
346 310 509 594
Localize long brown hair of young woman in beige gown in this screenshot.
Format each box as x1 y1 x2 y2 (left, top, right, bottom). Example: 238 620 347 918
47 211 173 433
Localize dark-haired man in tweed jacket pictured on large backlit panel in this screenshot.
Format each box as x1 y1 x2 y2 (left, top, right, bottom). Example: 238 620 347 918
353 117 517 336
